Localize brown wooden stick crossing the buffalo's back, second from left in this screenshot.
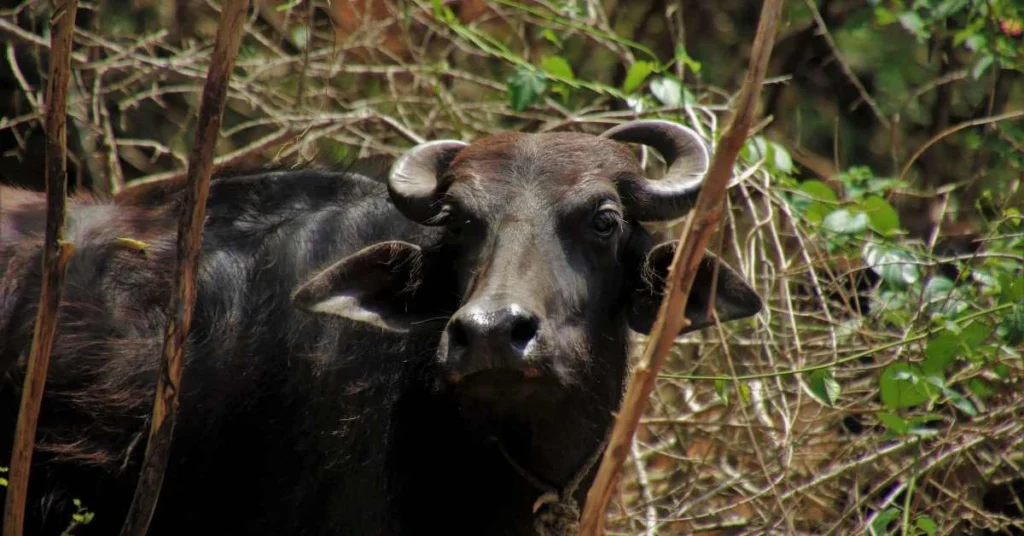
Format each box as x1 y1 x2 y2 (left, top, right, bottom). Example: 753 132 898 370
121 0 249 536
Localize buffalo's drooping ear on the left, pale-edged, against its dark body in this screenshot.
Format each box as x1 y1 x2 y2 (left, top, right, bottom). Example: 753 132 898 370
292 241 452 333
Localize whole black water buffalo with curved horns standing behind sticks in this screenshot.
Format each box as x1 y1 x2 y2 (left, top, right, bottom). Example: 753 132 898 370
0 121 762 536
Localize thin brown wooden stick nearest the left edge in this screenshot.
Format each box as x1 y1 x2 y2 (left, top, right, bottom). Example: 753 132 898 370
3 0 78 536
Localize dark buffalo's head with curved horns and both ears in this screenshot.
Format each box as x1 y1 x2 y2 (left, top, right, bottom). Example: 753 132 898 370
295 121 761 393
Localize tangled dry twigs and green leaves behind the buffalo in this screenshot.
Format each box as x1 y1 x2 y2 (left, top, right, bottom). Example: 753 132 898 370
0 0 1024 535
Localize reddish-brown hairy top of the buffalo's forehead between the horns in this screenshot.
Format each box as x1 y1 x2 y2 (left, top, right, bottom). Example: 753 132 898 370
451 132 640 192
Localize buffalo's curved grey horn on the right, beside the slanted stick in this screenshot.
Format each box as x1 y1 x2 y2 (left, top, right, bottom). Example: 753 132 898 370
601 120 711 221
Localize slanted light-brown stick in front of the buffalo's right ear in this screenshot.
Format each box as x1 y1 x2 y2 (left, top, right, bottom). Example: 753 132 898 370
580 0 782 536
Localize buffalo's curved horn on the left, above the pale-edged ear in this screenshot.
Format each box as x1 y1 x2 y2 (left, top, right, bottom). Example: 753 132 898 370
387 139 468 224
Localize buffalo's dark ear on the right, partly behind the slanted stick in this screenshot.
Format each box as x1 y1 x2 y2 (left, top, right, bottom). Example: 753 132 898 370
627 241 762 335
